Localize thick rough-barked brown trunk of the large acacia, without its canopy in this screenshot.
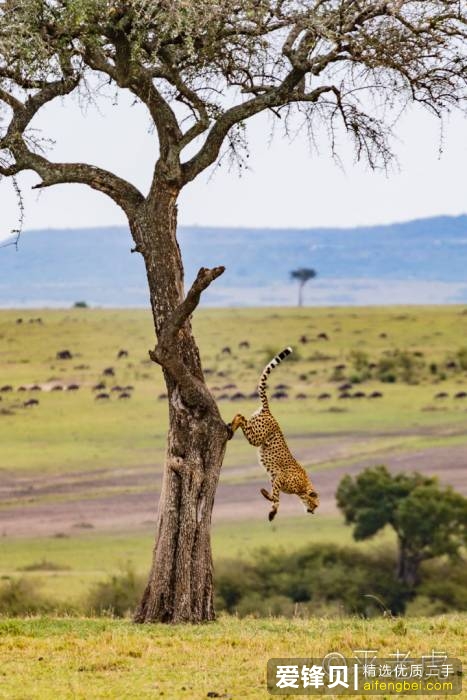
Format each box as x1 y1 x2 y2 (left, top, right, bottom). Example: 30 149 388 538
132 185 228 623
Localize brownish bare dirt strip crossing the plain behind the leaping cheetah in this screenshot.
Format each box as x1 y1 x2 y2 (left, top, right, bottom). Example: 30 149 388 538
0 434 467 536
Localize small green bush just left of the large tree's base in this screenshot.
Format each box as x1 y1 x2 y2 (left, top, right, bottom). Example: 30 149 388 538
85 565 145 617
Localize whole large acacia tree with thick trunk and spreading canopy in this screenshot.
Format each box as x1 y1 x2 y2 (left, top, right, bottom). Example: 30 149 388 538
0 0 466 622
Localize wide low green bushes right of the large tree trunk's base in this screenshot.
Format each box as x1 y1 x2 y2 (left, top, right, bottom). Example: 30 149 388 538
216 545 408 616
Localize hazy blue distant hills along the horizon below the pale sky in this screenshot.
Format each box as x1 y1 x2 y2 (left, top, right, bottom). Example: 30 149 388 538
0 215 467 307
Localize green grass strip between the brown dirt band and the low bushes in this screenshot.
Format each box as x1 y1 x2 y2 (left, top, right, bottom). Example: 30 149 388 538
0 516 394 604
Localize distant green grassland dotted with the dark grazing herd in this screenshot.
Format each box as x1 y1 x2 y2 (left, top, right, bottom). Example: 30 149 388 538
0 306 467 474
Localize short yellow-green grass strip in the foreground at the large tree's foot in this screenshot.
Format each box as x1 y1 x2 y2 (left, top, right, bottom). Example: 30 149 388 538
0 614 467 700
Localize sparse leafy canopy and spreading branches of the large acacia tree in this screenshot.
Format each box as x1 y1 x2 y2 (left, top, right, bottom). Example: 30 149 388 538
0 0 467 205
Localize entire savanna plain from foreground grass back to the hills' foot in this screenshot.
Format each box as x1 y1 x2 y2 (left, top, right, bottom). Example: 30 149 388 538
0 306 467 698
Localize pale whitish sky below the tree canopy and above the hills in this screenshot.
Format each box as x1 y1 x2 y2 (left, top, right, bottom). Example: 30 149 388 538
0 89 467 235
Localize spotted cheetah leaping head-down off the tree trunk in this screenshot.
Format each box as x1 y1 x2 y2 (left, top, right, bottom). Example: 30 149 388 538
229 348 319 520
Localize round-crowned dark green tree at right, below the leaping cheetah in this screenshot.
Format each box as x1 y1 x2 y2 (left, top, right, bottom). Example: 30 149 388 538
336 466 467 590
